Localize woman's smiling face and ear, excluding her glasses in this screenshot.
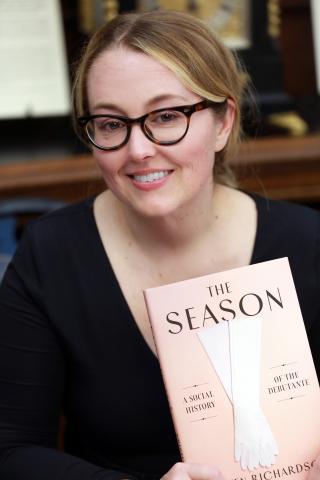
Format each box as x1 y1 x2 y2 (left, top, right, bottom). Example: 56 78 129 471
87 48 233 216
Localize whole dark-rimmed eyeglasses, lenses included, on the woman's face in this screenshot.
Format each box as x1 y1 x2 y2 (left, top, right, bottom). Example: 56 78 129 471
78 100 226 150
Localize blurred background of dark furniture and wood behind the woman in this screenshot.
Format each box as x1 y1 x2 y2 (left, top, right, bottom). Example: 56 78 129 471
0 0 320 276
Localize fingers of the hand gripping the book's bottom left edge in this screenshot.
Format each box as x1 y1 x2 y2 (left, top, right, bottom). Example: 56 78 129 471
161 462 224 480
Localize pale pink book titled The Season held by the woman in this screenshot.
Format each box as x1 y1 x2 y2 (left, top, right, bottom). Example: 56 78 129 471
144 258 320 480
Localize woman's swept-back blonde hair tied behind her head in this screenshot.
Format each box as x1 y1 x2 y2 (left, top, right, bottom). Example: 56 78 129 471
73 10 247 185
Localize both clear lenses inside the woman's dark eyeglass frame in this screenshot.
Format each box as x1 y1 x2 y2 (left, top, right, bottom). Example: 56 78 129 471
87 109 188 148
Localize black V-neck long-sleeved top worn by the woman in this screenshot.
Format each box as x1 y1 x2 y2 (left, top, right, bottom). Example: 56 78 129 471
0 196 320 480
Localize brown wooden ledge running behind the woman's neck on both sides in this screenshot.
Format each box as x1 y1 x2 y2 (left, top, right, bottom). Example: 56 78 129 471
0 135 320 203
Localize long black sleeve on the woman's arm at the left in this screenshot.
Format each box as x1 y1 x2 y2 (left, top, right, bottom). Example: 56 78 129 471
0 233 134 480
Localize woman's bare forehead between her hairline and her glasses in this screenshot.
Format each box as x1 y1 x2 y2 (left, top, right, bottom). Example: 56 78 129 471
87 48 198 107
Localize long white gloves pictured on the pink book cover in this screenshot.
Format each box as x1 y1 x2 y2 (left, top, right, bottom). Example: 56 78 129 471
198 317 278 470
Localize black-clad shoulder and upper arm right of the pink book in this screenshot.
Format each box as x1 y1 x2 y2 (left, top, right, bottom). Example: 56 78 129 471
252 194 320 328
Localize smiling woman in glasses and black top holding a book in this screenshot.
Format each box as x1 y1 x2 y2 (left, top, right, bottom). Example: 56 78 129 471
0 8 320 480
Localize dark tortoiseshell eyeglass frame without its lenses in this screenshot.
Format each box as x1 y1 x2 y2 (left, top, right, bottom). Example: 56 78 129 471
78 99 227 151
